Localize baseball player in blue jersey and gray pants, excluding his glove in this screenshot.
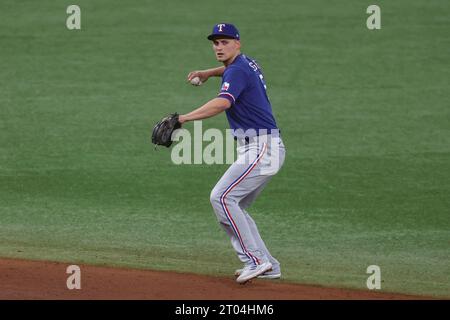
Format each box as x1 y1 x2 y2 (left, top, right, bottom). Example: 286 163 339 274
179 23 285 283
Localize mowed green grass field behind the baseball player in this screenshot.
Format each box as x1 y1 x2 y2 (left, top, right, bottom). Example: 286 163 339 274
0 0 450 297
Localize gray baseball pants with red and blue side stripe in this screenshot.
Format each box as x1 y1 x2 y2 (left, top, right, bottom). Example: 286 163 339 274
210 134 285 269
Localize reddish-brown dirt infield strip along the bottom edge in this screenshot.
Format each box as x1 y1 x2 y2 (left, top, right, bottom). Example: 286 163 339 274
0 259 423 300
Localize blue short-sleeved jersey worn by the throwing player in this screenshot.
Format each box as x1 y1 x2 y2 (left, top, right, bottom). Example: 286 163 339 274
218 54 277 133
